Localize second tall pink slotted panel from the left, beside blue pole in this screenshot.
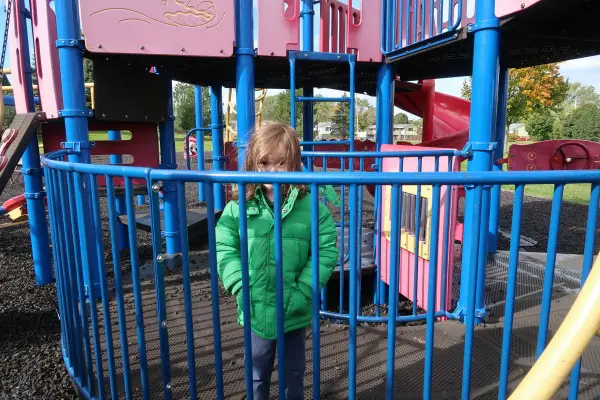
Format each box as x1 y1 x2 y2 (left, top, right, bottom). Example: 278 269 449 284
31 0 62 118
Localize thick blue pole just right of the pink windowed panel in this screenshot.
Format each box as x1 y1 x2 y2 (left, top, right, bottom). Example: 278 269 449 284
457 0 500 323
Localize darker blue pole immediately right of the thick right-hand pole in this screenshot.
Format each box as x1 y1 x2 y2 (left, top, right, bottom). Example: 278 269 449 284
488 67 509 253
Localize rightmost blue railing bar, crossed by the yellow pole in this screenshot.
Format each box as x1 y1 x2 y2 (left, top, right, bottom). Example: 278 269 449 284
569 184 600 400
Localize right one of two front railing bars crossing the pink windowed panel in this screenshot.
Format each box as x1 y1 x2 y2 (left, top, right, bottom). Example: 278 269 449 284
424 185 440 399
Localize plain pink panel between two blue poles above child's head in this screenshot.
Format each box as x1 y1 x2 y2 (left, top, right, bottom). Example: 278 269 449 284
258 0 300 57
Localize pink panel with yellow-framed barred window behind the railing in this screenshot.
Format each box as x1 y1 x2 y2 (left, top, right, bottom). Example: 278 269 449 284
380 145 460 311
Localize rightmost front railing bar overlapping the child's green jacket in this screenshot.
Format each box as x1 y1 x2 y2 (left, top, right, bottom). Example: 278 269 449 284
310 184 325 400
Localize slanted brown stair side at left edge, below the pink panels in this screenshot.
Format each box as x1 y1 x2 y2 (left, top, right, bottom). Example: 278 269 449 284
0 112 44 197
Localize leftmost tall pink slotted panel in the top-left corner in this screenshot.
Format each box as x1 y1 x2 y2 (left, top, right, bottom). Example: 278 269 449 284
8 1 29 114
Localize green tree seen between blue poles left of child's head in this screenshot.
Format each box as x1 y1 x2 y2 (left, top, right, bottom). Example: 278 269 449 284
173 83 211 132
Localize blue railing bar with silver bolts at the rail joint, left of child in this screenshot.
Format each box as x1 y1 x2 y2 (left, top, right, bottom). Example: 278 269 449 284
147 182 172 400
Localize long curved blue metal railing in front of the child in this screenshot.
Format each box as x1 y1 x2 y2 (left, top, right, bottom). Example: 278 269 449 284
42 151 600 399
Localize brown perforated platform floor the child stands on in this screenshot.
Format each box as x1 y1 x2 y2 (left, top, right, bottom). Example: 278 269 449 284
86 250 600 399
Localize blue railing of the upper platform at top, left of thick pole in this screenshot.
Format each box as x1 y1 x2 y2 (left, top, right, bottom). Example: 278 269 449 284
381 0 467 60
